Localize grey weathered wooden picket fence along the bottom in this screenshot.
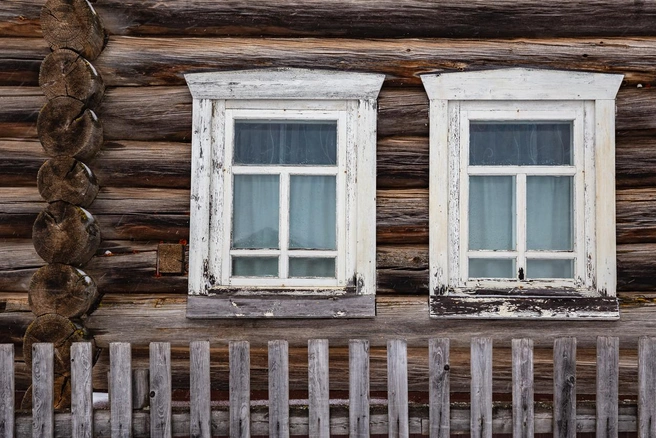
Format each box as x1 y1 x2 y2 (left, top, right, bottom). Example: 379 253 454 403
0 337 656 438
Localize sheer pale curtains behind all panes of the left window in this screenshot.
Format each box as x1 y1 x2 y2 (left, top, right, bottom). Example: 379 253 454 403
232 120 337 277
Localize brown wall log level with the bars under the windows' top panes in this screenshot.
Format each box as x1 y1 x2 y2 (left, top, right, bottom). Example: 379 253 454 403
0 131 656 189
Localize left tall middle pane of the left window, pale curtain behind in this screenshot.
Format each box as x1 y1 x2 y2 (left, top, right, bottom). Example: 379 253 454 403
232 175 280 249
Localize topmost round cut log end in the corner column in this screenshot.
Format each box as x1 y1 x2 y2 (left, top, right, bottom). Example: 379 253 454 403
41 0 107 61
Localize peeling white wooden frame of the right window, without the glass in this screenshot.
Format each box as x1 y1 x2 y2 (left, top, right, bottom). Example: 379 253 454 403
422 68 623 319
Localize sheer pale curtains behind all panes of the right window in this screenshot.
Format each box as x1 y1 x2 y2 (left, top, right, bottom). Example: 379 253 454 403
469 122 574 278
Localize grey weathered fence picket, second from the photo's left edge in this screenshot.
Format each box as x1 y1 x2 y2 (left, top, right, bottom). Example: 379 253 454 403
32 342 55 438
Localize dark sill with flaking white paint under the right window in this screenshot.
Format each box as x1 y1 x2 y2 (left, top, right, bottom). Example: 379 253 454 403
429 295 620 320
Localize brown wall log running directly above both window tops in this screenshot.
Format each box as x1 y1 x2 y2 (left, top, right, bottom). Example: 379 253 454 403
0 36 656 87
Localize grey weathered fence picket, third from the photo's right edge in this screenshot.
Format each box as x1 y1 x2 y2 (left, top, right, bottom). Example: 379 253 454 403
553 338 576 438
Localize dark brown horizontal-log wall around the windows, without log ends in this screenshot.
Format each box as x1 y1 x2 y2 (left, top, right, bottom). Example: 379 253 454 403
0 0 656 396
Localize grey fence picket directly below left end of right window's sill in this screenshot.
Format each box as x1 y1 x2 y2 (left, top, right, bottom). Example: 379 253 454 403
428 339 451 438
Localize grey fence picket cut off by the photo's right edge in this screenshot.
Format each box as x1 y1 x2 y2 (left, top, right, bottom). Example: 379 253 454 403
638 336 656 438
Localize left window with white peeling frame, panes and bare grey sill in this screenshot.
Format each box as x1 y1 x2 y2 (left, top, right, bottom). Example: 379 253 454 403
186 69 384 318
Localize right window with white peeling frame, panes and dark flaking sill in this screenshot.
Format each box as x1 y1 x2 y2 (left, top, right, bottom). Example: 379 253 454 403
422 69 622 319
